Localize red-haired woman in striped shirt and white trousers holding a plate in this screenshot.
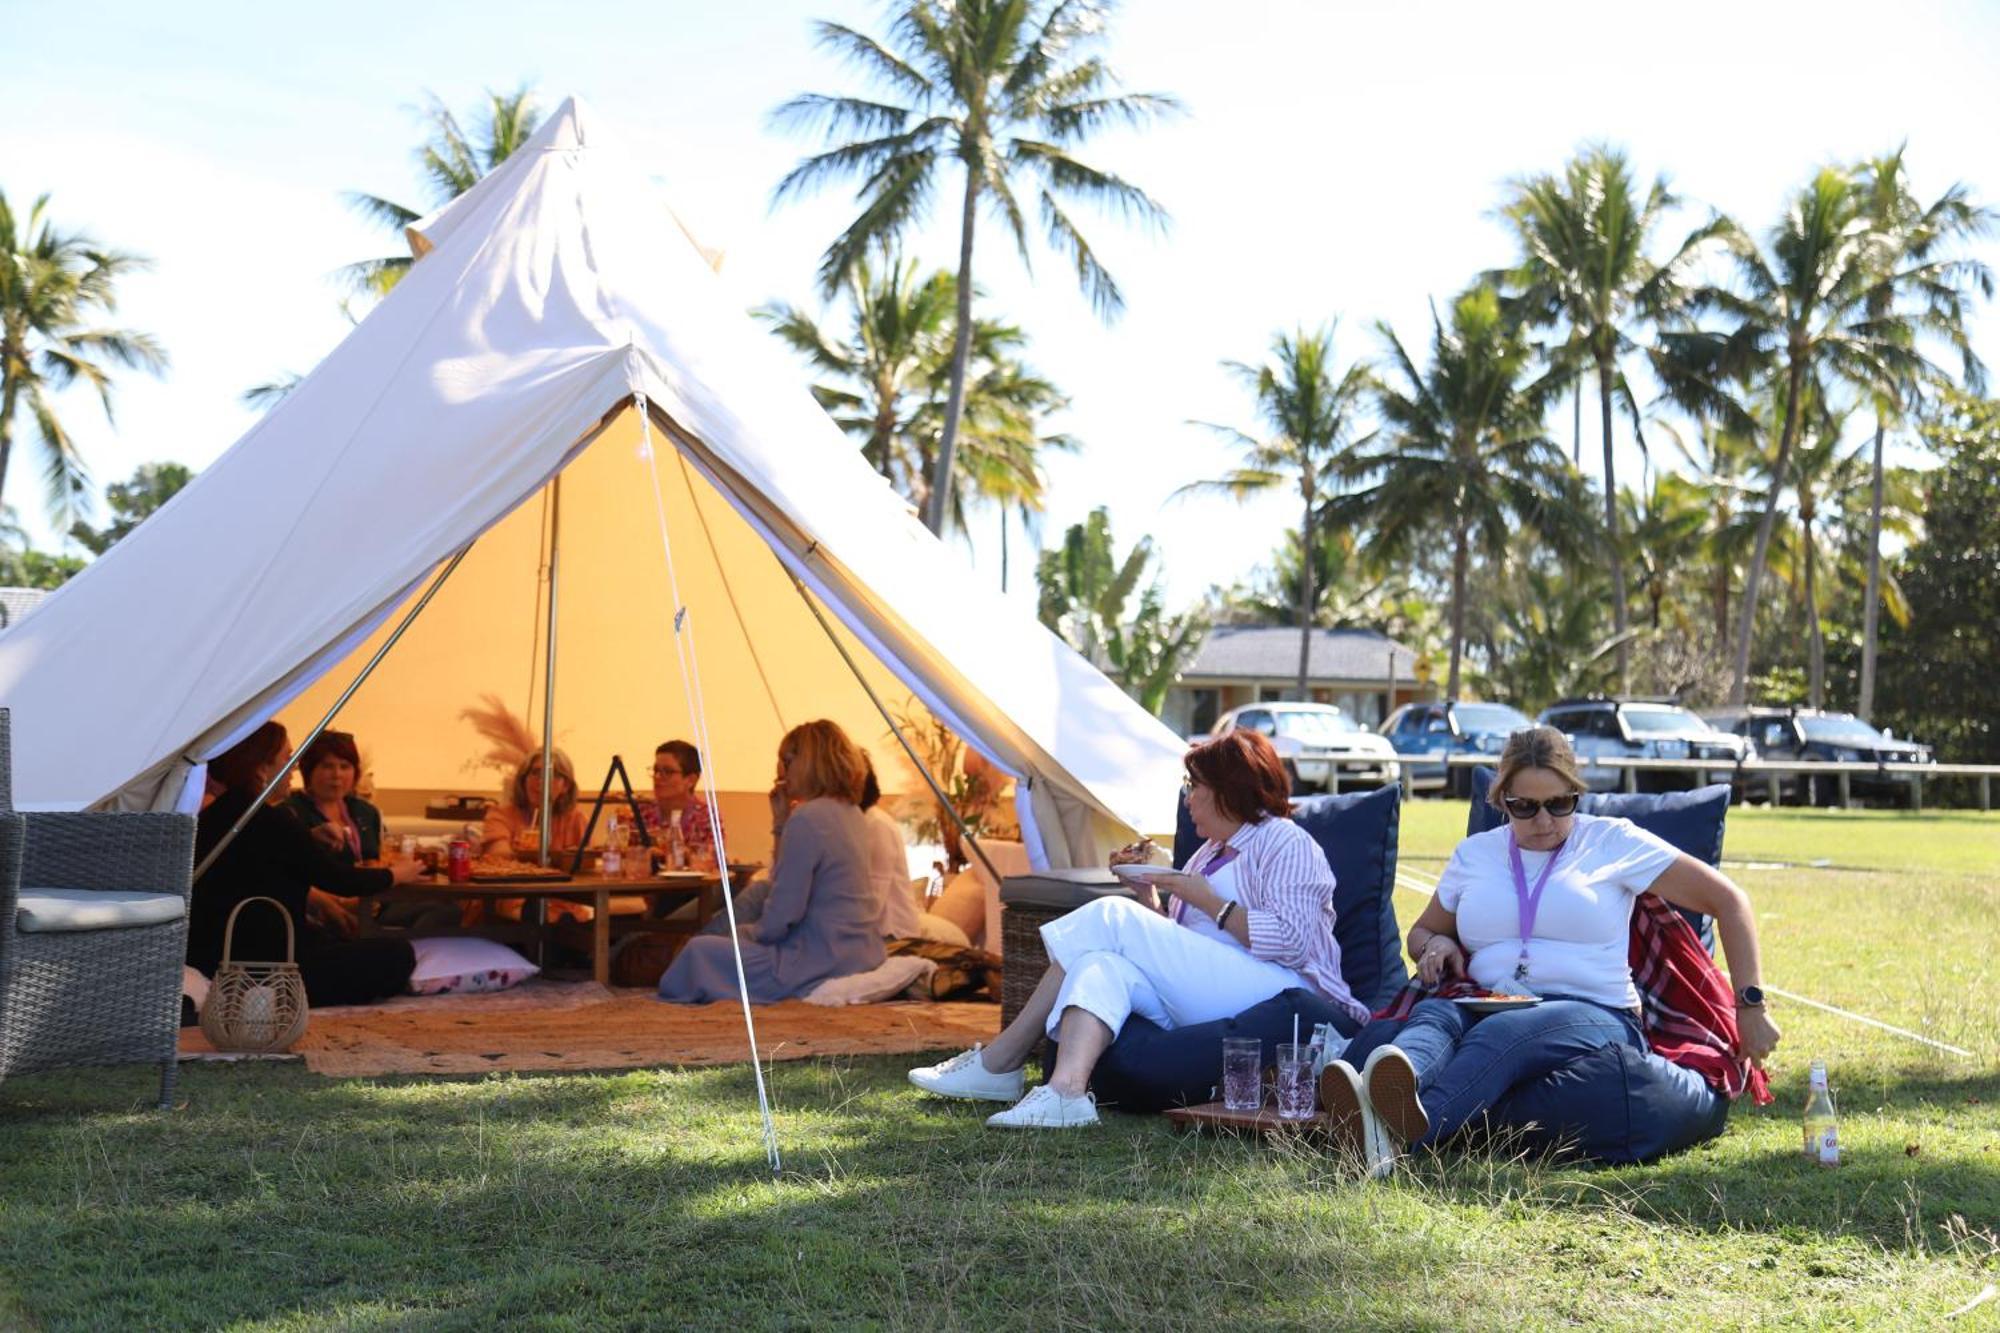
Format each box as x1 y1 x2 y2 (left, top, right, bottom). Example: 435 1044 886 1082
910 731 1368 1129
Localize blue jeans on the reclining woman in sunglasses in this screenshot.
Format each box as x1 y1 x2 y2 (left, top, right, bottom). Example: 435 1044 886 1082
1346 995 1646 1147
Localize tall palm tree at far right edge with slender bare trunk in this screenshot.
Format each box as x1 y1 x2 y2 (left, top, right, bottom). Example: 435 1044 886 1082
1856 148 1994 719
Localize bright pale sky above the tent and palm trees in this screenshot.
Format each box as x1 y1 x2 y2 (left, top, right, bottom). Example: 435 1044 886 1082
0 0 2000 596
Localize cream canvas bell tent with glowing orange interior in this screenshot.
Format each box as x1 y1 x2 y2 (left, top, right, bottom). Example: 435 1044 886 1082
0 93 1182 865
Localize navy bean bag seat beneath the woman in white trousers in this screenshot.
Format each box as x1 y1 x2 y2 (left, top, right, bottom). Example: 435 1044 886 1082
1080 987 1356 1113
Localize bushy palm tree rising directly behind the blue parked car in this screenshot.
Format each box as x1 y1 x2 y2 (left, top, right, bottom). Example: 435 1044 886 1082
1326 284 1588 699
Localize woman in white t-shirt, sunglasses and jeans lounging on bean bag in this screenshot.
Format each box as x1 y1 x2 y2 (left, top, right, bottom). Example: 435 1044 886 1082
1322 727 1778 1165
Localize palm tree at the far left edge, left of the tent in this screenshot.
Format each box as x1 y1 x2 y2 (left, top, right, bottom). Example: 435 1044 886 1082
0 194 166 526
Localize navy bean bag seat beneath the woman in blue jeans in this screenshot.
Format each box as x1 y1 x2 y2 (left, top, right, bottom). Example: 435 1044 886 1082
1488 1047 1730 1163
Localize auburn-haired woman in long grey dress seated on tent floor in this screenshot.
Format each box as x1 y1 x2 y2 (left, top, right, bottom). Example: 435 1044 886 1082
660 721 888 1005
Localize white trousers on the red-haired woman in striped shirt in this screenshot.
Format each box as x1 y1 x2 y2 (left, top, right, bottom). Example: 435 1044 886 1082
1042 899 1306 1037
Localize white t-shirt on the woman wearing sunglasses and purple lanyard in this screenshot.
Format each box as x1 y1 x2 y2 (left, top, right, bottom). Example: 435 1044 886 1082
1438 815 1680 1009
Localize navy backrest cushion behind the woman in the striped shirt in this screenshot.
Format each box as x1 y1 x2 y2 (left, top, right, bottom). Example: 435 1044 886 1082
1174 783 1410 1009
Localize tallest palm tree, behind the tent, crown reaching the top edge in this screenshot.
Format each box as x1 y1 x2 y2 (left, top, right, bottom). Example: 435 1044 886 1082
774 0 1178 532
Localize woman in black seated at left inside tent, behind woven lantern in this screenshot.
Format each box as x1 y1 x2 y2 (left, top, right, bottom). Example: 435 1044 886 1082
188 723 418 1005
